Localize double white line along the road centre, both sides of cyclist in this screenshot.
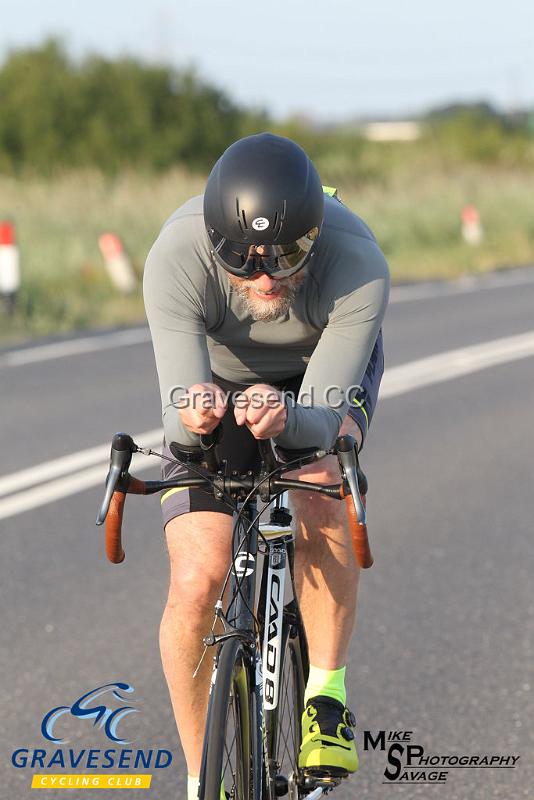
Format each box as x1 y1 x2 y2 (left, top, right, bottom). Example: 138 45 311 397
0 331 534 519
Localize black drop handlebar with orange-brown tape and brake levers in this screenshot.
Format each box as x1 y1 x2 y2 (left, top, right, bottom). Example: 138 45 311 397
96 429 373 569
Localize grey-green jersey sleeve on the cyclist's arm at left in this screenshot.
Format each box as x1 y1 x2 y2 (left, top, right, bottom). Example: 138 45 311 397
143 221 212 445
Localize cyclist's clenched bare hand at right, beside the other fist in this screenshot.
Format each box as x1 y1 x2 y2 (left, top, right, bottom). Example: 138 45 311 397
234 383 287 439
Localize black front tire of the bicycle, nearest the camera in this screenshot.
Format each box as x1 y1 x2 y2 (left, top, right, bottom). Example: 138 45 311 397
201 639 253 800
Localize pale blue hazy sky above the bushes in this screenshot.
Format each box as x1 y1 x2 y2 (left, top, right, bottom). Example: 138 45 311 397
0 0 534 122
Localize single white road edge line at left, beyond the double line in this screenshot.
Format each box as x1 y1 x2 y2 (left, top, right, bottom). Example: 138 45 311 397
0 328 150 367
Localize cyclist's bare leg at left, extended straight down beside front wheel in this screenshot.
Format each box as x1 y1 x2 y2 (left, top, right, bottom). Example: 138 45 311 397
160 511 232 775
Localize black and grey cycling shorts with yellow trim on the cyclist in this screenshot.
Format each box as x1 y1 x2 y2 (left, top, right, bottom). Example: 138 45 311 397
161 332 384 526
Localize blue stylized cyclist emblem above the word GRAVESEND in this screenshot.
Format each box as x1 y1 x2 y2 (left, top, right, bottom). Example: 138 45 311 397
41 683 139 744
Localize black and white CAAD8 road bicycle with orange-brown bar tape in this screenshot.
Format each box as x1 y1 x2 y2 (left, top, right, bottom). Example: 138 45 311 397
97 433 373 800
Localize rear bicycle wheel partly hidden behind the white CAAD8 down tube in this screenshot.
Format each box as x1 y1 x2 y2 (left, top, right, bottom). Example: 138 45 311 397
264 603 309 800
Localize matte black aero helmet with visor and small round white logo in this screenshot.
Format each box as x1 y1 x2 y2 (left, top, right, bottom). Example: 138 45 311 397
204 133 324 278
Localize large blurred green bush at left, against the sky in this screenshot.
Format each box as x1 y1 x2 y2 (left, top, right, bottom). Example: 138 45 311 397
0 40 263 173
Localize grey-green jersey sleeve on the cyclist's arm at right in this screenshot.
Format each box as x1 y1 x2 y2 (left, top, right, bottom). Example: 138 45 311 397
276 239 389 449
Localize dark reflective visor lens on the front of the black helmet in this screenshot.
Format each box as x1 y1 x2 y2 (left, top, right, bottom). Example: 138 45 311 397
208 228 319 278
